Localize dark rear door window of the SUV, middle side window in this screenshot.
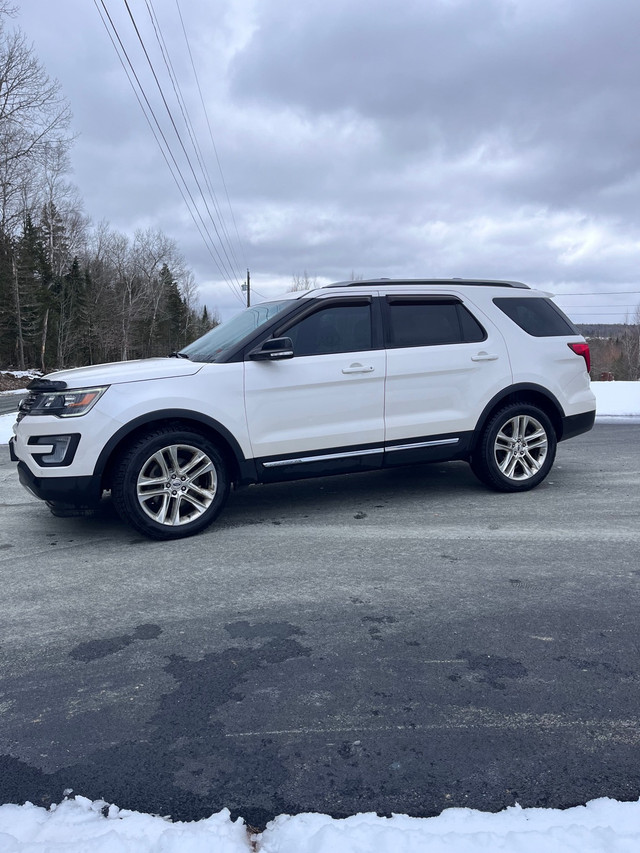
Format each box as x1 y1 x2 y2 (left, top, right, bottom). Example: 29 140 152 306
388 298 486 347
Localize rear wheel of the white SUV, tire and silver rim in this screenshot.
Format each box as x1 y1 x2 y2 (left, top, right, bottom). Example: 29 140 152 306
471 403 557 492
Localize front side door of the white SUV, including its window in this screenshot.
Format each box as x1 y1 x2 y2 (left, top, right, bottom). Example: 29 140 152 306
244 296 385 476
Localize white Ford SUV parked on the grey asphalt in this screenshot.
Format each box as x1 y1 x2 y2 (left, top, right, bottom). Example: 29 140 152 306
11 279 595 539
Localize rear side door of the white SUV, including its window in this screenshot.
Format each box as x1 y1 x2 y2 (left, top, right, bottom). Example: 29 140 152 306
383 294 511 464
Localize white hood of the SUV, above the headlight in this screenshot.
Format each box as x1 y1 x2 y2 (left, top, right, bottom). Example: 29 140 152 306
46 358 203 388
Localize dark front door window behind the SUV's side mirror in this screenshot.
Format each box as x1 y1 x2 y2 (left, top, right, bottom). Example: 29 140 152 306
282 301 372 355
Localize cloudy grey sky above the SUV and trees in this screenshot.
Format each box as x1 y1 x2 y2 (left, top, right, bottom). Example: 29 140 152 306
10 0 640 323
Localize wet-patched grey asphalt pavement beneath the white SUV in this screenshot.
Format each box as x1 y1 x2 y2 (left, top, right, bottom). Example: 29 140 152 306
0 425 640 826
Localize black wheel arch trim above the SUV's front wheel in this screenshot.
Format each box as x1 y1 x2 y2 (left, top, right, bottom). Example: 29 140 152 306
94 409 257 489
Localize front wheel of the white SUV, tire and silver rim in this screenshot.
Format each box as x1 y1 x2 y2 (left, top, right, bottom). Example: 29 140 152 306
111 427 229 539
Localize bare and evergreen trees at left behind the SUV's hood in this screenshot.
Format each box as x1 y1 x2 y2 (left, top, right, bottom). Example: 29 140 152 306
0 5 216 371
